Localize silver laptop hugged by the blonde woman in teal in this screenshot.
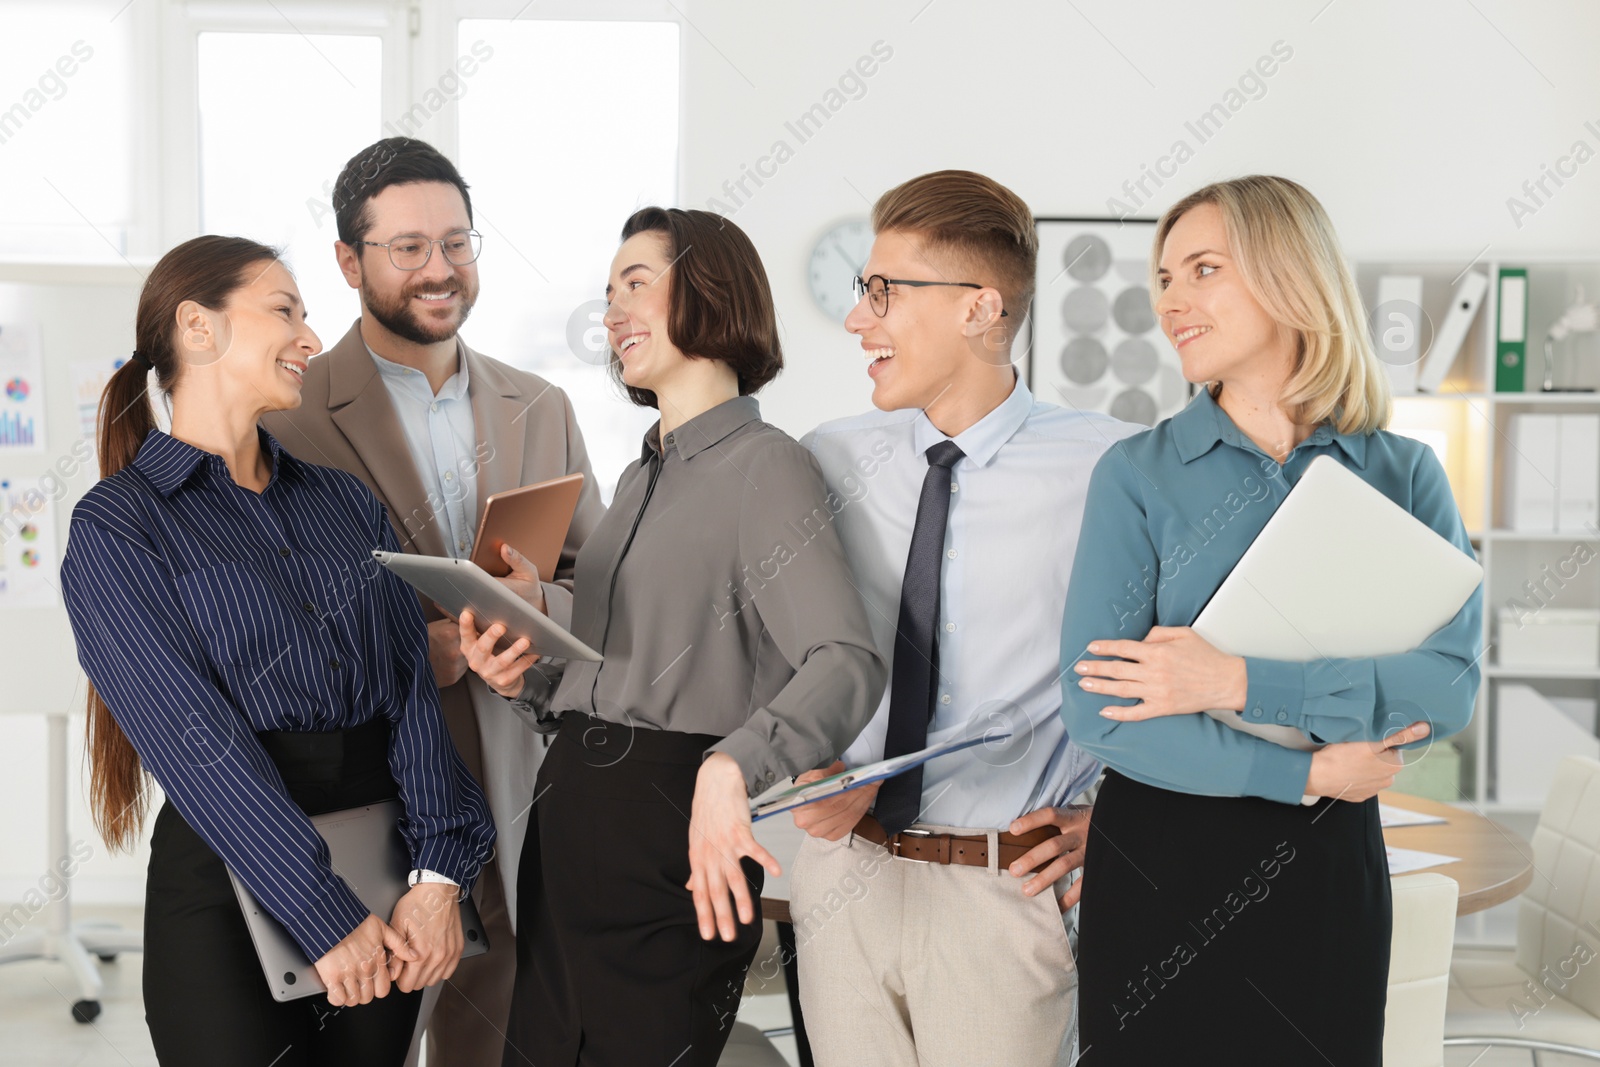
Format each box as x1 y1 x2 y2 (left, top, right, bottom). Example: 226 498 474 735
1194 456 1483 750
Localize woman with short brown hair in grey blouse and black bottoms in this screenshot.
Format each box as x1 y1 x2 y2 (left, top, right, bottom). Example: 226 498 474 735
461 208 886 1067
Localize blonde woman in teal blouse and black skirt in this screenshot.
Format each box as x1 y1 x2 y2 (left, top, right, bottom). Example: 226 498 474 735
1061 176 1483 1067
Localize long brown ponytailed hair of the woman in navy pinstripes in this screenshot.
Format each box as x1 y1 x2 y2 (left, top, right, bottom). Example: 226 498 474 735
85 235 278 849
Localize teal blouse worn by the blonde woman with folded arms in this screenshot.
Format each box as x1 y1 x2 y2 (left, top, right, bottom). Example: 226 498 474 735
1061 390 1483 803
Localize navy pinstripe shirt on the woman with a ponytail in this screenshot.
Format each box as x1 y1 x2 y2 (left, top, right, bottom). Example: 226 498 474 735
61 429 494 960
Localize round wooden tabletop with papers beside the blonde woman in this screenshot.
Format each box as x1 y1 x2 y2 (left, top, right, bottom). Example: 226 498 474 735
1378 792 1533 915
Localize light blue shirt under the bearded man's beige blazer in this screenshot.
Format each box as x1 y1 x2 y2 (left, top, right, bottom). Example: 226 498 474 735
366 346 478 560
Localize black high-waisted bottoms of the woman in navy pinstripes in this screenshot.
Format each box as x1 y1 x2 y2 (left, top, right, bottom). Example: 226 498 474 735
144 720 422 1067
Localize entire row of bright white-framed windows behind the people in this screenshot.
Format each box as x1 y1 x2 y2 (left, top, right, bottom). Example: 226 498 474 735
0 0 682 499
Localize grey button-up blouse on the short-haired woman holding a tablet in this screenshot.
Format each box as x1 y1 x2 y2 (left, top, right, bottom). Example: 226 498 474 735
512 397 888 795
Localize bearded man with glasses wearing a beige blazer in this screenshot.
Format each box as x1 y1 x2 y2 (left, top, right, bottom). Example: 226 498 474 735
262 138 603 1067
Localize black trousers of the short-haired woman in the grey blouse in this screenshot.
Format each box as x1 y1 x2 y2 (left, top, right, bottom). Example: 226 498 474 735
504 712 763 1067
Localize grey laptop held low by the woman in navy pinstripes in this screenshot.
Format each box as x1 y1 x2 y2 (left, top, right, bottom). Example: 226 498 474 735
227 800 490 1001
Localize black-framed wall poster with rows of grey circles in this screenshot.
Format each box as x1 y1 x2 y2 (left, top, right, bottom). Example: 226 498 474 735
1029 218 1192 426
